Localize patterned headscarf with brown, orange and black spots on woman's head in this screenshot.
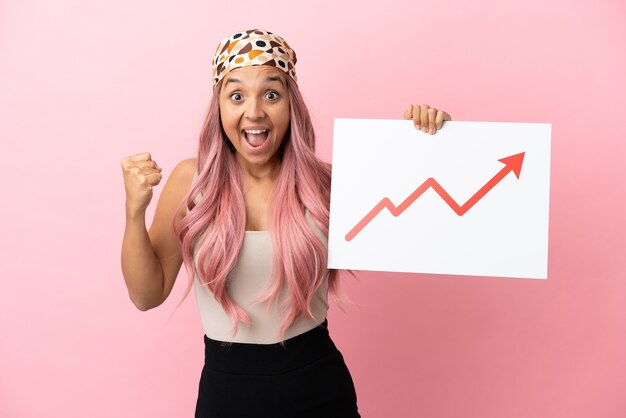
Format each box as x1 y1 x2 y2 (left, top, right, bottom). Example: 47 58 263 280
213 29 297 87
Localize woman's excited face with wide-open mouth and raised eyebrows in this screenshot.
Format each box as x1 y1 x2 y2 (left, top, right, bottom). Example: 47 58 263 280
220 65 289 171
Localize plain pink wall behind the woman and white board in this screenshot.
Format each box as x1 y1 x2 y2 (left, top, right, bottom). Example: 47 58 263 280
0 0 626 418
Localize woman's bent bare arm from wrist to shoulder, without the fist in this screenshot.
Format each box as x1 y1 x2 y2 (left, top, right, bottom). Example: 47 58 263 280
122 158 196 311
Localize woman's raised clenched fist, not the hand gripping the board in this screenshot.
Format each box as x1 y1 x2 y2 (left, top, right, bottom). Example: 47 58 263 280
122 152 162 211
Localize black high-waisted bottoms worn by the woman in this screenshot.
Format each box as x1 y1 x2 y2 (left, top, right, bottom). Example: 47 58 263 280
196 320 360 418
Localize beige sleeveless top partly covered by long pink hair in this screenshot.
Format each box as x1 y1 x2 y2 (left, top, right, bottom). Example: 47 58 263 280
192 173 328 344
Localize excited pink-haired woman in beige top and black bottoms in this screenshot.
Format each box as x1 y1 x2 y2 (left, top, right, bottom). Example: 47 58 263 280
122 29 450 418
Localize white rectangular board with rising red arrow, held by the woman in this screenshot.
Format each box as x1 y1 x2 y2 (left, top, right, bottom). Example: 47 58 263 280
328 119 551 279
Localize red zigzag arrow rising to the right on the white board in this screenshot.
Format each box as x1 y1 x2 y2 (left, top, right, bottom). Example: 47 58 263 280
346 152 525 241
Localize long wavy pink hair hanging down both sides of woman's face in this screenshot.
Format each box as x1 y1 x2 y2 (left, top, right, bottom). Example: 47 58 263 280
173 77 343 339
